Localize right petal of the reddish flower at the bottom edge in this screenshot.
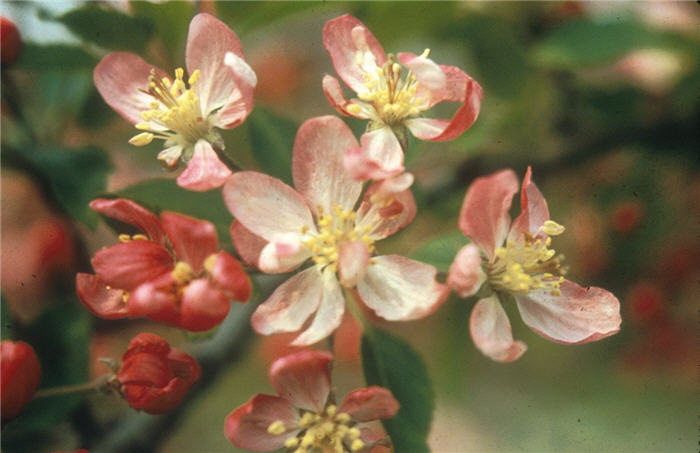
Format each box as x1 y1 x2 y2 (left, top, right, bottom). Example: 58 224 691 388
338 386 399 423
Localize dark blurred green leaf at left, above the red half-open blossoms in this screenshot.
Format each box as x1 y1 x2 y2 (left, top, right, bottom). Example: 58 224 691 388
9 146 112 228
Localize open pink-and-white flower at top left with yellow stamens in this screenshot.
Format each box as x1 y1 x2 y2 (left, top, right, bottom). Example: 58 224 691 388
94 13 257 190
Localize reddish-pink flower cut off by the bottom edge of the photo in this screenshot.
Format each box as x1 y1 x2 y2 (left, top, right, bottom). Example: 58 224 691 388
224 350 399 453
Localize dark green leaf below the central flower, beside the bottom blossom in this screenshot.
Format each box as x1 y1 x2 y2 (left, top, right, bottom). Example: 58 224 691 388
362 327 435 453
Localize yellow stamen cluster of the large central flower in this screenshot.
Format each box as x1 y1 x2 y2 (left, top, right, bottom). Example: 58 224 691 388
301 205 375 272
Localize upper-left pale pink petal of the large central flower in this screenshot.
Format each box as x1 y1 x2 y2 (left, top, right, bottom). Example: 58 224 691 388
223 171 316 242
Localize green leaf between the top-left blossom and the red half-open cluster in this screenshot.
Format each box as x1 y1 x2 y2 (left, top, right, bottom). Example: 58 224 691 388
112 178 233 243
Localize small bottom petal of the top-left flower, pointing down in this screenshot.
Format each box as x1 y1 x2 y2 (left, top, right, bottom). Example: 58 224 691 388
177 140 231 192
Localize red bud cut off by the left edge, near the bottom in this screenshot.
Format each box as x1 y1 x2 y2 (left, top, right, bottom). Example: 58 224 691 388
0 341 41 422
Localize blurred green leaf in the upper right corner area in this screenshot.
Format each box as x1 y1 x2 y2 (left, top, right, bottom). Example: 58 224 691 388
535 19 680 68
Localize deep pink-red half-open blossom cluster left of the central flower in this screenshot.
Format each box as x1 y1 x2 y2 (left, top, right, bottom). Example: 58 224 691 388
76 198 251 331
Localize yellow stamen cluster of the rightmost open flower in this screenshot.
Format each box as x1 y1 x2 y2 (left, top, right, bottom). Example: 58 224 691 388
488 220 566 296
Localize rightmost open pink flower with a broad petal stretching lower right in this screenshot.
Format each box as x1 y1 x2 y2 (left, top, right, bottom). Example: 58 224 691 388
447 168 621 362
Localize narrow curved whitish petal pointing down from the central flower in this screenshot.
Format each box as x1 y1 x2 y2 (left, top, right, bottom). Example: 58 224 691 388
290 269 345 346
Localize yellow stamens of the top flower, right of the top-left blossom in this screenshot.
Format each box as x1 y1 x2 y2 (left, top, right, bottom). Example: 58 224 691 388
348 49 430 126
